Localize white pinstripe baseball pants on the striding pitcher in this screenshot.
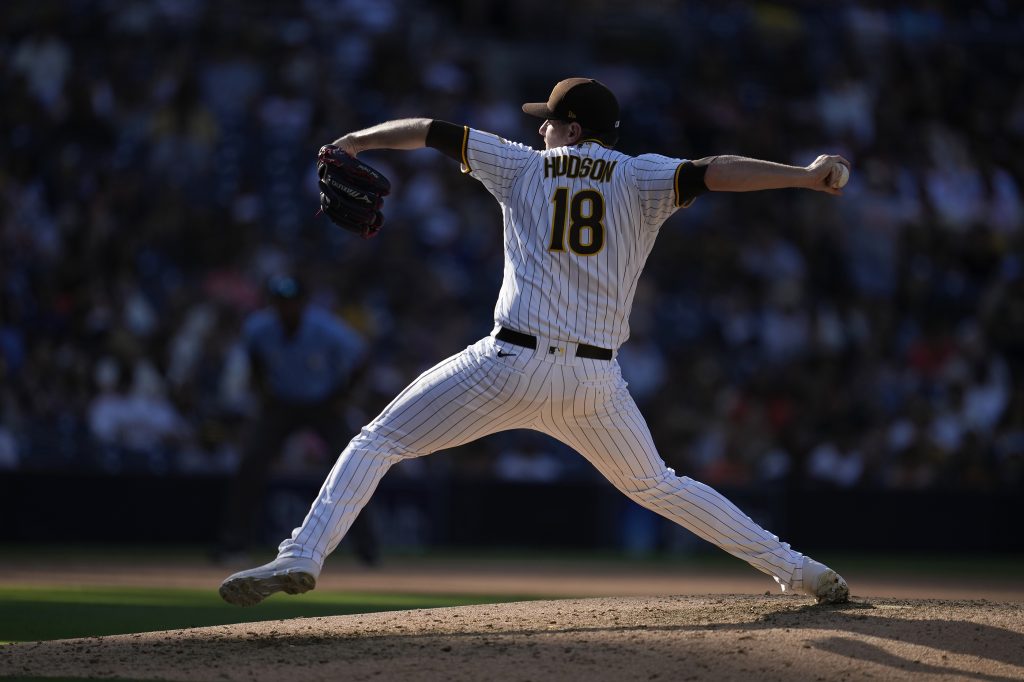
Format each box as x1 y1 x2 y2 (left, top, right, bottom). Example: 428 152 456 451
279 337 803 587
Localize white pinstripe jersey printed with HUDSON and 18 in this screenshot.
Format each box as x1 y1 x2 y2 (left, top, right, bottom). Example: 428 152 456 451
462 128 688 348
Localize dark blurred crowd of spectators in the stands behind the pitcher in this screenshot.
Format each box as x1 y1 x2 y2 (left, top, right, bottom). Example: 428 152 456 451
0 0 1024 491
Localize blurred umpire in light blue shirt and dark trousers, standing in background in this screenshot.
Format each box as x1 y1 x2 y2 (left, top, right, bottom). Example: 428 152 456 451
215 275 378 564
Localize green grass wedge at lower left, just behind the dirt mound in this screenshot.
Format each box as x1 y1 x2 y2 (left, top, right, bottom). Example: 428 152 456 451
0 587 523 643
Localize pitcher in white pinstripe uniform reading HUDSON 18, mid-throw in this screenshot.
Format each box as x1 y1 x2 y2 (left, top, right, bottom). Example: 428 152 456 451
220 78 849 605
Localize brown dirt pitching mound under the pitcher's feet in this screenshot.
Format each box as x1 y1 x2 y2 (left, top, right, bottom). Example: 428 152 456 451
0 596 1024 682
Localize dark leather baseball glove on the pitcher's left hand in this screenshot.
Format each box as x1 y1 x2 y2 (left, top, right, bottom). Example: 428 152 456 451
316 144 391 240
